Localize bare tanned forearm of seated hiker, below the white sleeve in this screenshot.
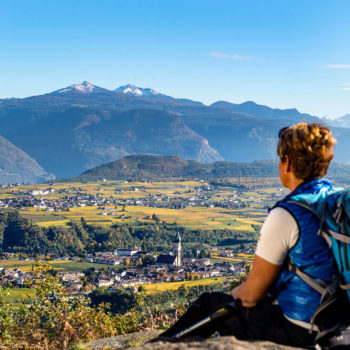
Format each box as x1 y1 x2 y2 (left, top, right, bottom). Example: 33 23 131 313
231 255 281 307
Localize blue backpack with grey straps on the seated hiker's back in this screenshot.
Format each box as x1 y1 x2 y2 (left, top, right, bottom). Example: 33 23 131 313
289 188 350 349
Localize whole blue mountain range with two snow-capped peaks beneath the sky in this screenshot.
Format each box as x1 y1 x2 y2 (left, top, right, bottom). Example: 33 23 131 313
0 81 350 182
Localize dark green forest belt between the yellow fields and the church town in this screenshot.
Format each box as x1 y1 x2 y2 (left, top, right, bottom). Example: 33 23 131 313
0 211 256 255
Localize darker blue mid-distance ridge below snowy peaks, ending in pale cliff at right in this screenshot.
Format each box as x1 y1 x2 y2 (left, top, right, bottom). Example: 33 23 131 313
3 107 223 177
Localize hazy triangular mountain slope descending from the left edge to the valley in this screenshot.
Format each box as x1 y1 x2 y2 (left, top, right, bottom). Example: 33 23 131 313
0 136 54 184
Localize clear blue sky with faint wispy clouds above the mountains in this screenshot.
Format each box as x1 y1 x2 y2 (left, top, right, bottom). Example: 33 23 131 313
0 0 350 117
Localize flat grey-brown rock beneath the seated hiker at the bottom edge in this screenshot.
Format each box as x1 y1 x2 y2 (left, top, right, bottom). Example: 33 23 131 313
85 330 302 350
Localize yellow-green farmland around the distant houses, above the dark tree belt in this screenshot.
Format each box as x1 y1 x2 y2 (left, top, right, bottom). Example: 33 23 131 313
5 181 282 232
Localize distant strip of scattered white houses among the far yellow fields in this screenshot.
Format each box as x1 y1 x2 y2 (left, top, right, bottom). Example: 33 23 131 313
0 184 253 211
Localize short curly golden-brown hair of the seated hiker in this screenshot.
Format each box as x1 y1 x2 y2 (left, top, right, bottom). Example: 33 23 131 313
277 123 337 180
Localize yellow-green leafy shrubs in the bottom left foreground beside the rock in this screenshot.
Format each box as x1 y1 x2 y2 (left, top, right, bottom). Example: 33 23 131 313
0 262 142 349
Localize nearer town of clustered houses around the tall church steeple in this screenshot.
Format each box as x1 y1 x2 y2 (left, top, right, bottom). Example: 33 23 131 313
0 237 253 294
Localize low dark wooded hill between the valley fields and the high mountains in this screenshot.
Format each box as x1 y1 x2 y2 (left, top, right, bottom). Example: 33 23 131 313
66 155 350 181
